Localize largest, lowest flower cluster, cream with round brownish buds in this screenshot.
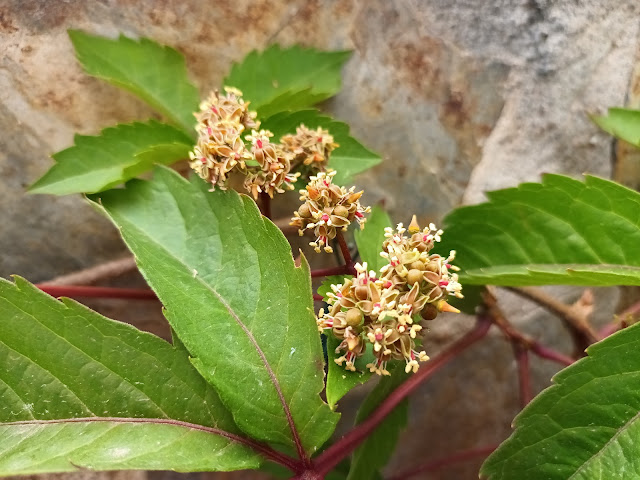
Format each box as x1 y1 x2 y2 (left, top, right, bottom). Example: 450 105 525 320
317 217 462 375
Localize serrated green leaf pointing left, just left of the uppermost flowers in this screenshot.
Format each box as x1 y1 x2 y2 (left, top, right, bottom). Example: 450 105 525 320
29 120 192 195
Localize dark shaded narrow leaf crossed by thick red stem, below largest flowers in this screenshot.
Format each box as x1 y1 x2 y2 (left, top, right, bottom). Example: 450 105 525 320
347 365 409 480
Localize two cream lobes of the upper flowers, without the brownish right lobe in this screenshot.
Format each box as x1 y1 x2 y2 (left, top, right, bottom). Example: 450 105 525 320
189 87 298 198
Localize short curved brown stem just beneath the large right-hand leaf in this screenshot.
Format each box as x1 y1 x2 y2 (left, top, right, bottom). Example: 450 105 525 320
508 287 598 350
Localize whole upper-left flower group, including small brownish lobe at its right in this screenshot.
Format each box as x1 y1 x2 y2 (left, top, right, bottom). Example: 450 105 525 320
189 87 338 198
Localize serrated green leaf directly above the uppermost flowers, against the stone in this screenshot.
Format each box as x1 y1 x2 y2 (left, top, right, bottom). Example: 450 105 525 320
224 45 351 117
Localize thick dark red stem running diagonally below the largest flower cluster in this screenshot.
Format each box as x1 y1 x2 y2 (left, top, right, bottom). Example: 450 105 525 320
314 317 491 475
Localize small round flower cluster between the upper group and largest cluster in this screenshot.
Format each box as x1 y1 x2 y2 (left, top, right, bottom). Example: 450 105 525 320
290 171 371 253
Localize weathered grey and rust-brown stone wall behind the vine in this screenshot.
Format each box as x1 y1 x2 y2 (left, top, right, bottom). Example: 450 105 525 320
0 0 640 480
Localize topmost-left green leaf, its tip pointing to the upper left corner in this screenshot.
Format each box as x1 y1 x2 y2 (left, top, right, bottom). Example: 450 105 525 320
69 30 200 138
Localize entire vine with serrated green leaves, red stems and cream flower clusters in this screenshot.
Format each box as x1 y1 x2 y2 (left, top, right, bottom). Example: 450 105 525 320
0 31 640 480
